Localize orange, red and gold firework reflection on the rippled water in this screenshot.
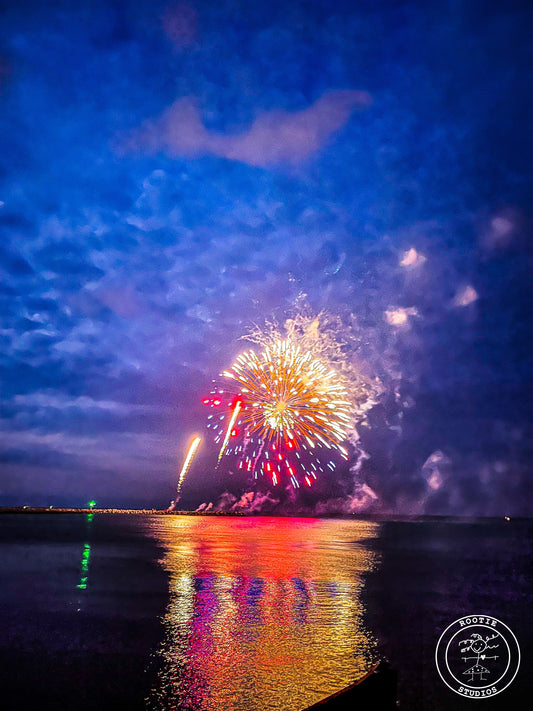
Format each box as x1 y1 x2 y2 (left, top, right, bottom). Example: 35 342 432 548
148 516 379 711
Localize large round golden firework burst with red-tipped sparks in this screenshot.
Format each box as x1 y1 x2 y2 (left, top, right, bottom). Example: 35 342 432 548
203 317 376 488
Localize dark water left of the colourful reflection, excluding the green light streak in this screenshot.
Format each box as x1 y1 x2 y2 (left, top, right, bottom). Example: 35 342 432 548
0 516 168 711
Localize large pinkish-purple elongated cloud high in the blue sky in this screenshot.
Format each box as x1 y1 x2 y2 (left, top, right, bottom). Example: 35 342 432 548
121 90 371 167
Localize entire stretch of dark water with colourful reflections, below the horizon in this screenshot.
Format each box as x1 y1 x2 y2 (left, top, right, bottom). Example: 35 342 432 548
0 514 533 711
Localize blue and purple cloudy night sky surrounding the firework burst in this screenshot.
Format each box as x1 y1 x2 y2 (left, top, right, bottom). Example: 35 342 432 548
0 0 533 515
